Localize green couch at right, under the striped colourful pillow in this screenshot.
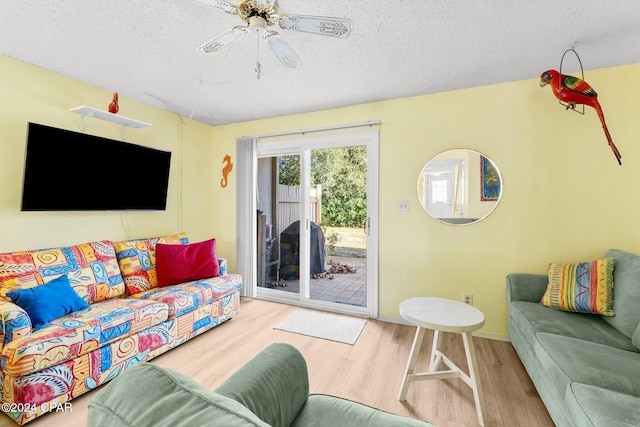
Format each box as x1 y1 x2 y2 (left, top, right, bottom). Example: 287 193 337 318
507 249 640 427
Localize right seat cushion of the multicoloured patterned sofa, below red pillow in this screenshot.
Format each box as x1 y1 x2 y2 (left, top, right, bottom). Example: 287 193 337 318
131 274 242 319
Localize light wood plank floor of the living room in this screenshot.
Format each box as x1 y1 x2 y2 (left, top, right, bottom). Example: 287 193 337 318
5 298 554 427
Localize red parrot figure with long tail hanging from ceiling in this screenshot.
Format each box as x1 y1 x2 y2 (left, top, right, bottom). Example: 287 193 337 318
540 70 622 165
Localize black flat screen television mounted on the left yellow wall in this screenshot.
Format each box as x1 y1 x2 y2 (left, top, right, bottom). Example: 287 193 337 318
21 123 171 211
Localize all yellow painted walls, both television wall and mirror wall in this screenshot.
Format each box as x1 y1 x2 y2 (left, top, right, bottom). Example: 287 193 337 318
5 51 640 338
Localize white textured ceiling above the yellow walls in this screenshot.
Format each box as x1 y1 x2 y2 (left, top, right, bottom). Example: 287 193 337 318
0 0 640 125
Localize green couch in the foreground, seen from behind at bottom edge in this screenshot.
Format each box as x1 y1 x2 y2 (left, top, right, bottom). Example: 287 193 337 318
89 343 432 427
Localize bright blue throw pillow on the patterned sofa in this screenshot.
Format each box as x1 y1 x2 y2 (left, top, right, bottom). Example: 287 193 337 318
7 274 89 329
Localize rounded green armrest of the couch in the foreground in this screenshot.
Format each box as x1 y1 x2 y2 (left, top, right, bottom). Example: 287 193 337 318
215 343 309 426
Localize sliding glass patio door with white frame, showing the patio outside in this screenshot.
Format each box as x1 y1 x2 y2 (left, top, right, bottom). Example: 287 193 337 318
256 132 377 316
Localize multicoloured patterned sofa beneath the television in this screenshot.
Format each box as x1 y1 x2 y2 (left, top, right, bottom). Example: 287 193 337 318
0 233 242 424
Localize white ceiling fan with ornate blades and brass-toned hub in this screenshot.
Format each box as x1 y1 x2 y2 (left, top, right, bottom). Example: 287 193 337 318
194 0 351 72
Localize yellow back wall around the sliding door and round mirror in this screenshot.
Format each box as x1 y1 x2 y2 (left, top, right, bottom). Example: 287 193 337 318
213 64 640 338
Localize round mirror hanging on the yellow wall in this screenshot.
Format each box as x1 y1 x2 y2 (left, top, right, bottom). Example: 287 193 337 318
418 148 502 225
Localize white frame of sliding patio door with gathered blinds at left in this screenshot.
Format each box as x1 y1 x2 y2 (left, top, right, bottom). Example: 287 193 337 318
236 130 379 318
